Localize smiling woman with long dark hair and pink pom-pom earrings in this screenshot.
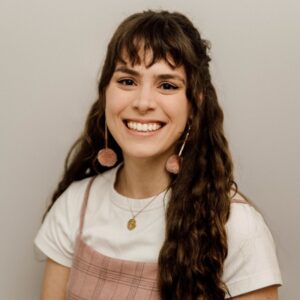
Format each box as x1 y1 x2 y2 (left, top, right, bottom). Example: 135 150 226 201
35 11 281 300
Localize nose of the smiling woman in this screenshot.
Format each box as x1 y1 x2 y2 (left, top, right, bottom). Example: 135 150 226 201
133 86 156 112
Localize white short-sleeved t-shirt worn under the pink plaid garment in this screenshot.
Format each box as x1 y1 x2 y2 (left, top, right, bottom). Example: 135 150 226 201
35 167 282 296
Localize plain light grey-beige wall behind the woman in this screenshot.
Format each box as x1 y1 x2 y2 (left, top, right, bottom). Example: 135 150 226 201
0 0 300 300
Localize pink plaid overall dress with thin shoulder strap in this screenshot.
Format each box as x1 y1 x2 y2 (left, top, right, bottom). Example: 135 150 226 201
67 177 160 300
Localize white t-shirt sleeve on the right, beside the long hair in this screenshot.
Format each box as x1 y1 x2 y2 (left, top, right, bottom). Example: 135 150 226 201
223 203 282 298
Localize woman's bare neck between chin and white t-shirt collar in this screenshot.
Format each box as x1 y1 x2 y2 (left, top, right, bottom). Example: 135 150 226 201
115 157 170 199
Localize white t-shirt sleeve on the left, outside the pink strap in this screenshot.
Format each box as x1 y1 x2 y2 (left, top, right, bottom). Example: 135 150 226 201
34 182 85 267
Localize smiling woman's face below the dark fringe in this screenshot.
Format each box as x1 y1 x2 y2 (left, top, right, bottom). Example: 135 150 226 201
105 55 189 163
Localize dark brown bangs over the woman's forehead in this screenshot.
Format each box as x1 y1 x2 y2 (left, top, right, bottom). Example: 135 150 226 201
114 15 192 68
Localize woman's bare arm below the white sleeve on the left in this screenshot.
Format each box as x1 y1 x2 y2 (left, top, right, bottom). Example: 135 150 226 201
41 258 70 300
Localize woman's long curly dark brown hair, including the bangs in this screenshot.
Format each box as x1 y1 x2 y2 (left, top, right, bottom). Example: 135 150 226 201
45 11 236 300
